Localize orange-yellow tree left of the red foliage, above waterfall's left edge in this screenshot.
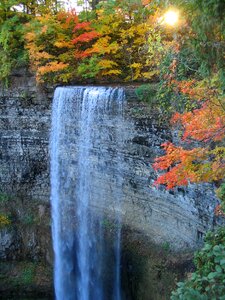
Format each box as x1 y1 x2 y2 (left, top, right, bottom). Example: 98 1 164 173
26 11 78 82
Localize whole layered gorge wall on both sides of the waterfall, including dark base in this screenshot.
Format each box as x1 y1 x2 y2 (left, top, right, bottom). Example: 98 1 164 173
0 70 223 300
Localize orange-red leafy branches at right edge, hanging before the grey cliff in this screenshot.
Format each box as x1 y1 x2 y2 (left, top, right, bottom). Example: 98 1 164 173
154 75 225 189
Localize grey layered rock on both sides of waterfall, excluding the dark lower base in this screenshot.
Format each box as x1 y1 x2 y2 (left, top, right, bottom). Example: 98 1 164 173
0 69 221 260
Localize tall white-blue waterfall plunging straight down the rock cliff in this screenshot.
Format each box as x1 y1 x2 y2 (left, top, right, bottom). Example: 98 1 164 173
50 87 125 300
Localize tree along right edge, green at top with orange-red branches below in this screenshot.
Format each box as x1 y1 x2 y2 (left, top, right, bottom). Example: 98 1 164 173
154 0 225 211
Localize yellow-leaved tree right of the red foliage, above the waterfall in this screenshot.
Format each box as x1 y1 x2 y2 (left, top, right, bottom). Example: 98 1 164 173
74 1 160 81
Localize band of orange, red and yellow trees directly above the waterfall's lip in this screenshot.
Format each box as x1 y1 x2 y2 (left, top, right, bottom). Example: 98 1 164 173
22 1 163 82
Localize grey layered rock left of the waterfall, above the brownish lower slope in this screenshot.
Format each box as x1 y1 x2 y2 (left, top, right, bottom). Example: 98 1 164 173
0 73 51 201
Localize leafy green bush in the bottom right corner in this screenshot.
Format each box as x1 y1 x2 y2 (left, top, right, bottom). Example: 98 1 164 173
171 227 225 300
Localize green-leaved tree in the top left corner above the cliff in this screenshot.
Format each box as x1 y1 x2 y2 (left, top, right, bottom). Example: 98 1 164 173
0 0 64 84
